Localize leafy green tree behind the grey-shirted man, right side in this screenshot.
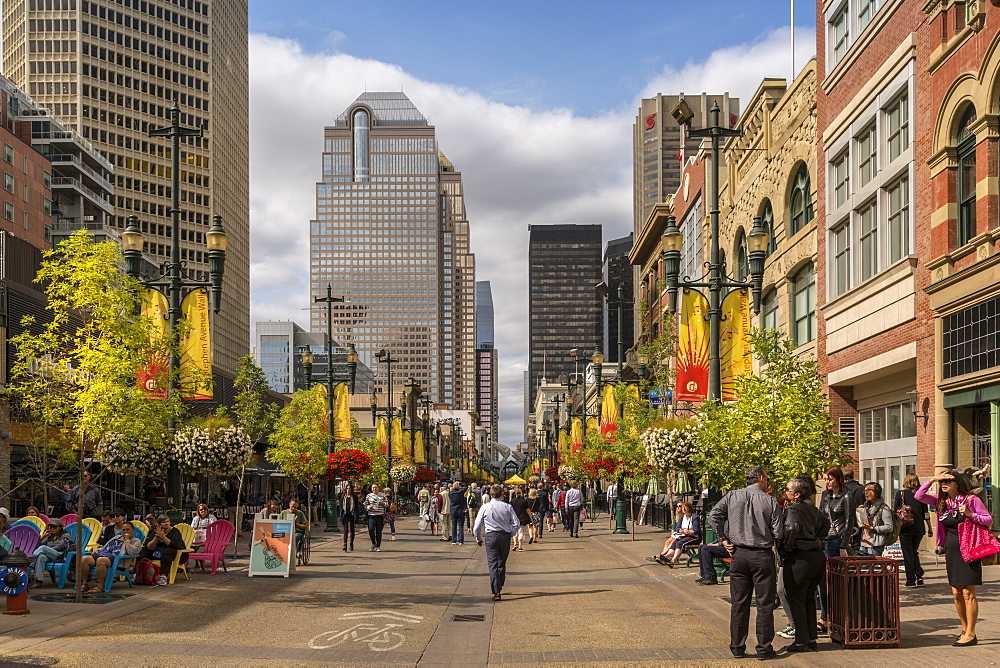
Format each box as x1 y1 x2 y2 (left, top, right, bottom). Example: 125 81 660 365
697 330 851 491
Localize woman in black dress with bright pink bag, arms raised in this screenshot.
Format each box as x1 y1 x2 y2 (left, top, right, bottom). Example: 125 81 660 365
913 470 993 647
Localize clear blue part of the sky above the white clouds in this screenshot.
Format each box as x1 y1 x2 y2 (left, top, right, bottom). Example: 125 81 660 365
250 0 815 115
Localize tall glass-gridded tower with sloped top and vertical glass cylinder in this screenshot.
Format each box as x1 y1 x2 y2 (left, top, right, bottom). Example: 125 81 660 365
310 92 476 410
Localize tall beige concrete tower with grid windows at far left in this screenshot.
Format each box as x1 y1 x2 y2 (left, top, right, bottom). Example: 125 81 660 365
0 0 250 372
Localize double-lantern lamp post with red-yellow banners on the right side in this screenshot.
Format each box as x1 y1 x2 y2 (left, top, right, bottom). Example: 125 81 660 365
663 103 769 401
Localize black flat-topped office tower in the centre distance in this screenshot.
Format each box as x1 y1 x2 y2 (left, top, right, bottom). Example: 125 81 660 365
526 225 602 412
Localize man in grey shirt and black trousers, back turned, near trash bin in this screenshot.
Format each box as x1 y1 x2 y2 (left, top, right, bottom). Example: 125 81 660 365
710 466 784 660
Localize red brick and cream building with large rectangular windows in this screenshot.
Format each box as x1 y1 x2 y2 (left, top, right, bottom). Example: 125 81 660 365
816 0 935 498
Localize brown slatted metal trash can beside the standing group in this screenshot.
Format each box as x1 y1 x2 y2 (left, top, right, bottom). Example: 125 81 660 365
826 556 900 647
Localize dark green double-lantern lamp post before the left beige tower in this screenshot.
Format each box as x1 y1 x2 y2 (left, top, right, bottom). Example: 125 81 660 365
121 102 228 507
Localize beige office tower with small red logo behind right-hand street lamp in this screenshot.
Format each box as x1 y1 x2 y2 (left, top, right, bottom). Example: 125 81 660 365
632 93 740 234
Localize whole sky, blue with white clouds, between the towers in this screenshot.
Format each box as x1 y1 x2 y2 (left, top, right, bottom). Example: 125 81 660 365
250 0 815 446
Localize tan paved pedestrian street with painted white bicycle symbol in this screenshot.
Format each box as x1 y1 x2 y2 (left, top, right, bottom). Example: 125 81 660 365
0 516 1000 667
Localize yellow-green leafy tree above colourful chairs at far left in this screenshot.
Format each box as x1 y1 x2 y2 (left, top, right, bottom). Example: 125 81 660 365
9 231 184 600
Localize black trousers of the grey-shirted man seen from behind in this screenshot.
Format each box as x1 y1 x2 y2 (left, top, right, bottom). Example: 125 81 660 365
729 547 778 654
